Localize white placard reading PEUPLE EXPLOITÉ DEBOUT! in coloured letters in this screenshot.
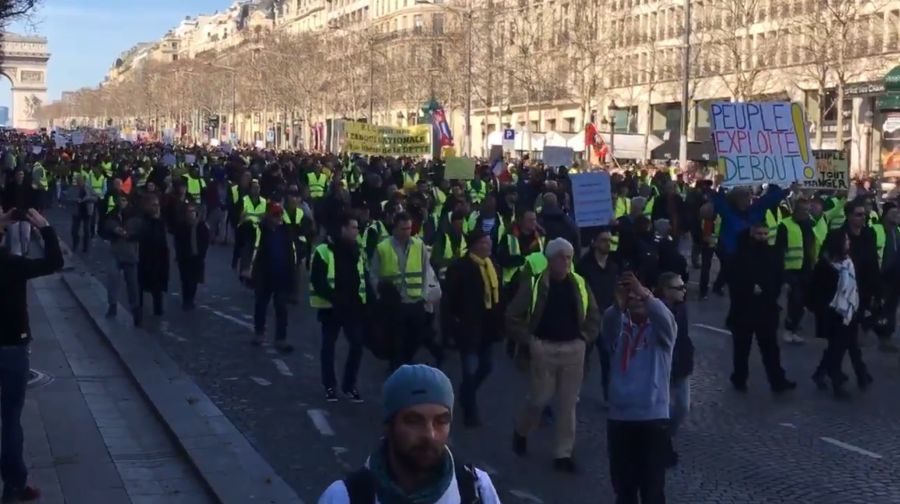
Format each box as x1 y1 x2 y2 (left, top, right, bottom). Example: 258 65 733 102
710 102 816 187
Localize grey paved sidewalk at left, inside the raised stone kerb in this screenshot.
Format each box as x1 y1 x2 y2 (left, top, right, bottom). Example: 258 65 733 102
22 276 215 504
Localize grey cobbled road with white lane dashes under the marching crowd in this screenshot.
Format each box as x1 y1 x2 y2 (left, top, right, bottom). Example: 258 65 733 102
45 207 900 504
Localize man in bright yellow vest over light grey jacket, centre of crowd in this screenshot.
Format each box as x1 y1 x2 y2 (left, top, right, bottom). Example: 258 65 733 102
369 212 429 369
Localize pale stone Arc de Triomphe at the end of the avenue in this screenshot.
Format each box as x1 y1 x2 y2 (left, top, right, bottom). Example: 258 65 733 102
0 32 50 129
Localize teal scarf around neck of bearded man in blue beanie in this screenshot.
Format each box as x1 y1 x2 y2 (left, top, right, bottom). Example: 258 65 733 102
369 441 454 504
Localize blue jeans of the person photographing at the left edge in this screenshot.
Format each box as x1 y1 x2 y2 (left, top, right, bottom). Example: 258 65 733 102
0 345 29 492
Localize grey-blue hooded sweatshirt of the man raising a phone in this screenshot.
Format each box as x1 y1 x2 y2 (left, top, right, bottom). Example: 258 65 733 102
600 296 678 421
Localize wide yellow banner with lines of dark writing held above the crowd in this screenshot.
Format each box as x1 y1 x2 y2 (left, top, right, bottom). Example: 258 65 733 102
344 121 431 156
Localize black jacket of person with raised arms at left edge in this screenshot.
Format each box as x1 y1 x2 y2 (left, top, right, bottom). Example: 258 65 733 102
0 227 63 346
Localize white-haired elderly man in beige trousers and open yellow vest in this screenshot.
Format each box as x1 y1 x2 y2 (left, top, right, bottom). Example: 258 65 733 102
506 238 601 473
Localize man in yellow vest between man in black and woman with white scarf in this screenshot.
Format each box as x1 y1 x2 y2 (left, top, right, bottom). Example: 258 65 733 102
775 199 818 344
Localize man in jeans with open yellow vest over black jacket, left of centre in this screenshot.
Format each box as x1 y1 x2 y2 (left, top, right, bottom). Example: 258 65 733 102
309 215 371 403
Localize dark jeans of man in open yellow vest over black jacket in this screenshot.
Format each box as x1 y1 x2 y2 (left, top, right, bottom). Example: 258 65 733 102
319 309 363 392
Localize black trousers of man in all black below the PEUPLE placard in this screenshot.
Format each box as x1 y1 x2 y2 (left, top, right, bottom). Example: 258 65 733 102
731 308 785 385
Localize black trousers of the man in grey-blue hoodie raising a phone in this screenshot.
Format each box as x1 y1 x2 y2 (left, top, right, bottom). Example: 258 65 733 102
606 420 671 504
